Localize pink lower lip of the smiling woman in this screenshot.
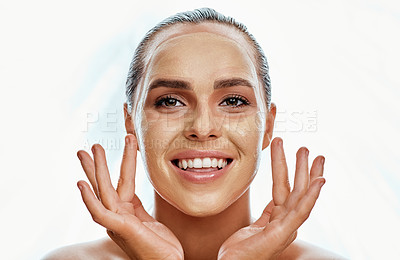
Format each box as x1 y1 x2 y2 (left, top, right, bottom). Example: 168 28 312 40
170 160 235 183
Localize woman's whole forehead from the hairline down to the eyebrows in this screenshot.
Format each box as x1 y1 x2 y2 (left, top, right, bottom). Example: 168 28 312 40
144 22 257 84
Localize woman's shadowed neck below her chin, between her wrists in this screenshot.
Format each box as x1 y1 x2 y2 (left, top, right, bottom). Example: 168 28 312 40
154 190 251 259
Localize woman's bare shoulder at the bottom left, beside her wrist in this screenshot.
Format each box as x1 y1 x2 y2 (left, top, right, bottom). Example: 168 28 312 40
42 237 129 260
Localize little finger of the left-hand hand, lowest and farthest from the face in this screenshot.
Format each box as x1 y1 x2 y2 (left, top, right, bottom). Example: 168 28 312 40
78 181 127 230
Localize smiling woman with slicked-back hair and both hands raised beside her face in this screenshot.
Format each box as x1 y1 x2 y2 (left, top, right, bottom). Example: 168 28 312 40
46 8 340 259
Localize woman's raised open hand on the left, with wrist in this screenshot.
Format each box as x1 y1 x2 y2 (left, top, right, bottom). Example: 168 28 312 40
78 135 184 260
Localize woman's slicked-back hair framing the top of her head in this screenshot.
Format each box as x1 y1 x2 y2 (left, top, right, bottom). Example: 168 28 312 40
125 8 271 113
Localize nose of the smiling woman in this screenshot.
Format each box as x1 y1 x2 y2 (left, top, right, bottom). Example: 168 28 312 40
184 104 221 141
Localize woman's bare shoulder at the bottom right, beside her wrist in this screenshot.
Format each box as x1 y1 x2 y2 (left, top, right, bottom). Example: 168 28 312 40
279 239 346 260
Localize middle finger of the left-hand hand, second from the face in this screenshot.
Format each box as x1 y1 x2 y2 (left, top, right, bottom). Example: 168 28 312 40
92 144 119 211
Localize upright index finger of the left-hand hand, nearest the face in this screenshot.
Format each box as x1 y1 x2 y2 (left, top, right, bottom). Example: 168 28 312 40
117 134 137 201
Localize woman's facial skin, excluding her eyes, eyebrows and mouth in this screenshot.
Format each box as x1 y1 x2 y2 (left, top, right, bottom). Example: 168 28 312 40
136 32 268 217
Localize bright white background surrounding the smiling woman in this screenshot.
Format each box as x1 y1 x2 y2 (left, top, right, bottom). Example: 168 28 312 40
0 0 400 259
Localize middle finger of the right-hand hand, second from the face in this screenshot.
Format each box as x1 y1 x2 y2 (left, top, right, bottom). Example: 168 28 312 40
293 147 310 200
